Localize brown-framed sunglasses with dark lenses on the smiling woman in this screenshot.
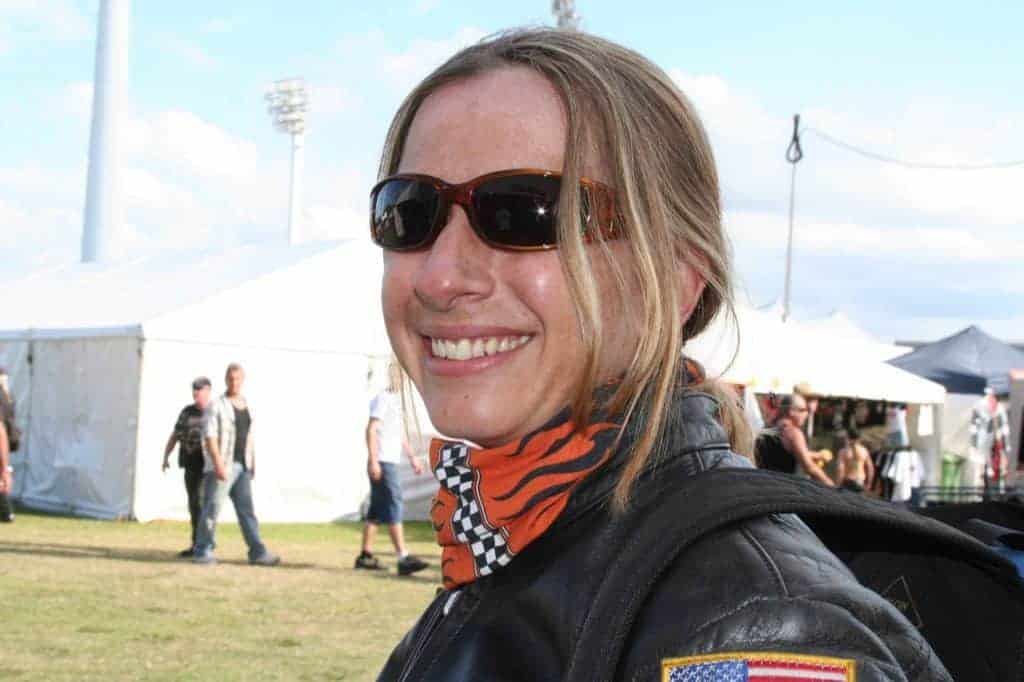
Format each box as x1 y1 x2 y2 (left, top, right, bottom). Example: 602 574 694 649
370 169 618 251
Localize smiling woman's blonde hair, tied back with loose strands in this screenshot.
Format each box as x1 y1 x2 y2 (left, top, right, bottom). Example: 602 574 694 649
380 29 749 506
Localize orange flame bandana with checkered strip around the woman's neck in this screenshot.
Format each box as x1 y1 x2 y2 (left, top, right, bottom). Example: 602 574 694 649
430 420 618 590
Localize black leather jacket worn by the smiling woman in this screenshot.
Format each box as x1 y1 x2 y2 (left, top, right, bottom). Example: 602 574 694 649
378 393 950 682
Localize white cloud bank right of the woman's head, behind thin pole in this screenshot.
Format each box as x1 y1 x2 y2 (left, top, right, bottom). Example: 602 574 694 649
672 71 1024 339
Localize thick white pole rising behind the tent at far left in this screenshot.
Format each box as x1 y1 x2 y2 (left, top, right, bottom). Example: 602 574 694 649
82 0 131 263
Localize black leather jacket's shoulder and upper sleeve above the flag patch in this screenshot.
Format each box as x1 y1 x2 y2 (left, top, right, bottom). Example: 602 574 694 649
621 515 949 682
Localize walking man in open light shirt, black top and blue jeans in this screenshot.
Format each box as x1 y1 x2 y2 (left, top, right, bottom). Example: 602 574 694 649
193 363 281 566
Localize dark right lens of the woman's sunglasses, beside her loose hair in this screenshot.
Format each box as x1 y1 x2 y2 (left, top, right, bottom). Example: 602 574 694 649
473 175 561 248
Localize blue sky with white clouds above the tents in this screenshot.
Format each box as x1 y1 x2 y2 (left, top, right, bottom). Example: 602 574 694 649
0 0 1024 340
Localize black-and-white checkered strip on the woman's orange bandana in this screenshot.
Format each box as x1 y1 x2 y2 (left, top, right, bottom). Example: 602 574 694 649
434 443 513 576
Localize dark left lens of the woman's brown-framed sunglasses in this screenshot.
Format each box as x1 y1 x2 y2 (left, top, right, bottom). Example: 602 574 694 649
371 178 440 251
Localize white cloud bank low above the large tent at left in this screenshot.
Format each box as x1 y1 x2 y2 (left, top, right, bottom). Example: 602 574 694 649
0 98 371 276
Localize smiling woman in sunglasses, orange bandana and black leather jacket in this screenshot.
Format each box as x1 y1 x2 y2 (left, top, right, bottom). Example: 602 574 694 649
371 30 947 680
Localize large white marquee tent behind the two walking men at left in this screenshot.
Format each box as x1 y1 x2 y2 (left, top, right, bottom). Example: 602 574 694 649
0 242 390 521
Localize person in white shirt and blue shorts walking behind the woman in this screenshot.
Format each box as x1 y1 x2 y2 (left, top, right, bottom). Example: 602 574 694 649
355 363 428 576
